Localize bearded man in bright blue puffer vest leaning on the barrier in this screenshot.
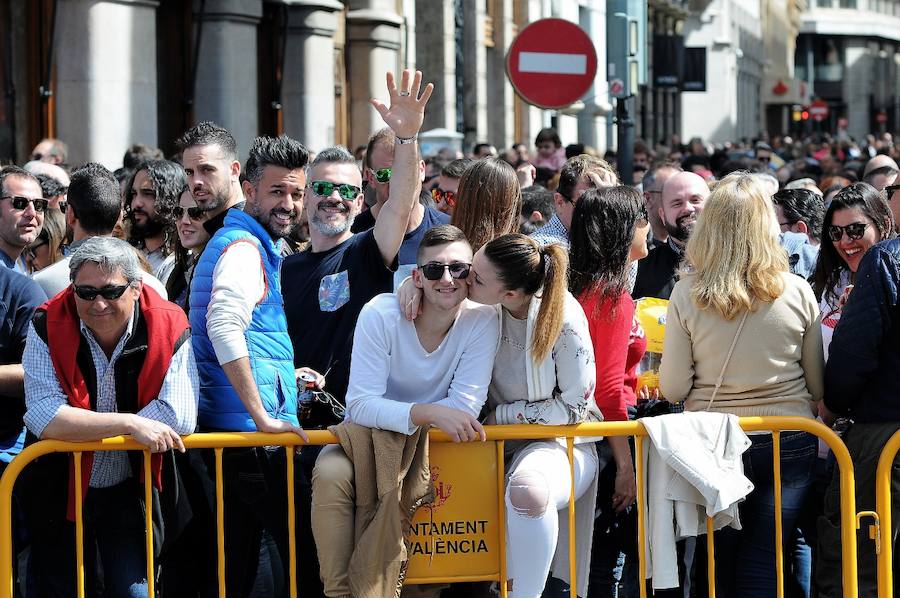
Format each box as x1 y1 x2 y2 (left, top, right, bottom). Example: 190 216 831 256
186 137 309 596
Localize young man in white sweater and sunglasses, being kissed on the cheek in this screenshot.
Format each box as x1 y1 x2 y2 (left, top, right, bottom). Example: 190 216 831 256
312 225 500 596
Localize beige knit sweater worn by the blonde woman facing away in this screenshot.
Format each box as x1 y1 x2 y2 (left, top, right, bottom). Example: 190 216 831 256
659 272 825 417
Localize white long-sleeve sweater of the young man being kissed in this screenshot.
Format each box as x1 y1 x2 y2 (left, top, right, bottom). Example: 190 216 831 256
346 294 500 434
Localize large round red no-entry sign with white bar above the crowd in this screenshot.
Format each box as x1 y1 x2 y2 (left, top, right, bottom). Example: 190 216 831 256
506 19 597 108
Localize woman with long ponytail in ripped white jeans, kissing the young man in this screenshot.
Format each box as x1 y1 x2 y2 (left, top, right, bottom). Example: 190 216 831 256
469 234 602 598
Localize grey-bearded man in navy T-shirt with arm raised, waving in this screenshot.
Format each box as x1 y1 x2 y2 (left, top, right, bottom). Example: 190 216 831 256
282 71 433 442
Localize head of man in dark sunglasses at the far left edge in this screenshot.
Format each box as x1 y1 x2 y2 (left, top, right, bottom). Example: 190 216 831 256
0 166 47 274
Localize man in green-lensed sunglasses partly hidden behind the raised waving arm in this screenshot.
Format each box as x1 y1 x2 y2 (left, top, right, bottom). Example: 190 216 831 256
350 127 450 287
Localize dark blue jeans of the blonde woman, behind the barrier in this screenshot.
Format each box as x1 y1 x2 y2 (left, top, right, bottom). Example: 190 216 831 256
696 432 818 598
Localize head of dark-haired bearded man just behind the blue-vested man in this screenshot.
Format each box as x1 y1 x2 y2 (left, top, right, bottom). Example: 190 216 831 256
175 121 244 236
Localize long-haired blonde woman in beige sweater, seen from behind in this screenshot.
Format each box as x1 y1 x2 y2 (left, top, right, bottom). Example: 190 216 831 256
660 172 824 598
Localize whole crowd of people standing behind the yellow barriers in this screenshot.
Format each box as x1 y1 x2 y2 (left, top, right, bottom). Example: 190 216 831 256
0 71 900 598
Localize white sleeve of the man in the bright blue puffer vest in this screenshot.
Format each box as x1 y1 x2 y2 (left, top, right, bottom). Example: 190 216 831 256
206 241 266 365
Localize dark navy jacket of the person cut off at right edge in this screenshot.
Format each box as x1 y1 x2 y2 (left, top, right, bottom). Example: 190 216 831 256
825 239 900 423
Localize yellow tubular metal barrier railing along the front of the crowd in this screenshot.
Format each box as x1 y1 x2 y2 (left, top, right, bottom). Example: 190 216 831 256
0 417 860 598
